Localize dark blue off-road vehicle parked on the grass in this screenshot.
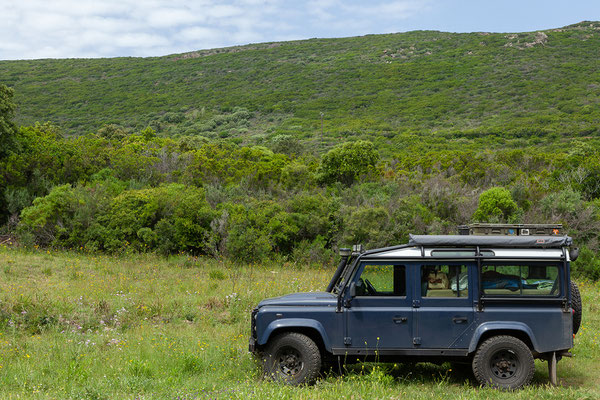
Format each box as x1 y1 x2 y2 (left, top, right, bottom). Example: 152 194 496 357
250 228 581 389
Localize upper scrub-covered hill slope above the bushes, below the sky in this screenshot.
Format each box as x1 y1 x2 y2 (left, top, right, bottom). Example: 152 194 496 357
0 22 600 143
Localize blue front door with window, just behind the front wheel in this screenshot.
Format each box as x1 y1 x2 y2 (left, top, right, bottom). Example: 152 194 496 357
344 262 413 350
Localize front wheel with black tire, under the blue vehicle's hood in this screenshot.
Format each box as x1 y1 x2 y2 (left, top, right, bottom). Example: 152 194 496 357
263 332 321 386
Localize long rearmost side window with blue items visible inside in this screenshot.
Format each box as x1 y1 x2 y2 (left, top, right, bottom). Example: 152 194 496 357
481 264 560 296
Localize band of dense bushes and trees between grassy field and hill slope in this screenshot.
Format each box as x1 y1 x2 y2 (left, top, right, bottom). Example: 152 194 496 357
0 85 600 279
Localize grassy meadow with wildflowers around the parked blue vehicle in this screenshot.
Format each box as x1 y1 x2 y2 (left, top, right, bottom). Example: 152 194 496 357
0 247 600 399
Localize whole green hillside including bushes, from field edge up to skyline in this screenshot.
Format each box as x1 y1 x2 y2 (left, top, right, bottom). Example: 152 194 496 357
0 22 600 280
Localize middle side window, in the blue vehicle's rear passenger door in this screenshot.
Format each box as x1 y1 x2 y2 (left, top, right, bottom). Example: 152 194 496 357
421 265 469 297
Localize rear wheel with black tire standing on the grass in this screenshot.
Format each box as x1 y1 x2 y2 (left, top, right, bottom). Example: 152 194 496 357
473 336 535 390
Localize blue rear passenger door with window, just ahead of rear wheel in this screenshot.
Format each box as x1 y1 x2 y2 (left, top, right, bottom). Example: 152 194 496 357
414 261 476 349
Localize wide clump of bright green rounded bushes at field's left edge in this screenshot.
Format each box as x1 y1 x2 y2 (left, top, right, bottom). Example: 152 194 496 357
19 180 215 254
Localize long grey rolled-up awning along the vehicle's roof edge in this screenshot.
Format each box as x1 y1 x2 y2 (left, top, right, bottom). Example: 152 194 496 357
408 234 573 248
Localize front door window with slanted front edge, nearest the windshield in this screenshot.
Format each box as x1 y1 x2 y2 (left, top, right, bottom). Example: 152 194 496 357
356 264 406 296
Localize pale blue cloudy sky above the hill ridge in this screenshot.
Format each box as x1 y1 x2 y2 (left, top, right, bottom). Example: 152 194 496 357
0 0 600 60
